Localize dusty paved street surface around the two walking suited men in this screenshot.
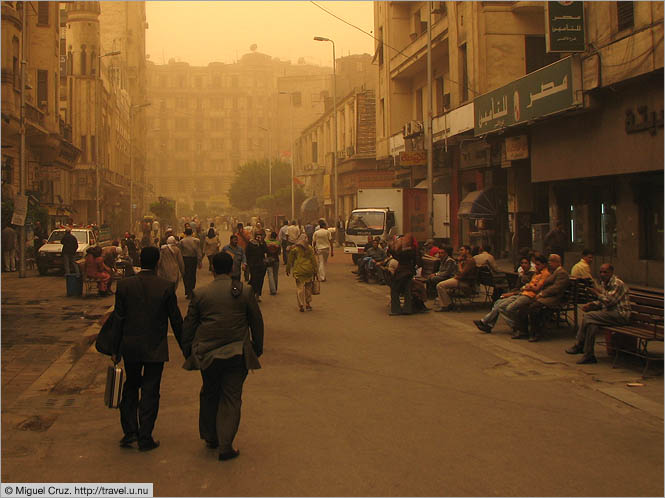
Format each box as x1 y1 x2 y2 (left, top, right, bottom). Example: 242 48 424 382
2 251 663 496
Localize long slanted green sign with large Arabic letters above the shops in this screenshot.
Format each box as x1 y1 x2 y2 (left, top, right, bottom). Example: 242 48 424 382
473 57 581 136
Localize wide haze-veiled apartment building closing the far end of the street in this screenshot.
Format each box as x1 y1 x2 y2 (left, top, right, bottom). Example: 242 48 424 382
146 51 331 210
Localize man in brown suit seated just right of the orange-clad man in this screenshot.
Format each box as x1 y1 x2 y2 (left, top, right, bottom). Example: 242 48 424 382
512 254 570 342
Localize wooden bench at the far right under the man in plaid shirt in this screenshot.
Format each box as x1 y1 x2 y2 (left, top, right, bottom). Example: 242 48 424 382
599 287 663 377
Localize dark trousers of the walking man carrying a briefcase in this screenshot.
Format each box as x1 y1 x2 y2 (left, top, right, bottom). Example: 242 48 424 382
120 361 164 442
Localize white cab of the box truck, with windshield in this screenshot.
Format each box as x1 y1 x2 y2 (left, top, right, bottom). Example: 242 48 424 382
344 207 396 263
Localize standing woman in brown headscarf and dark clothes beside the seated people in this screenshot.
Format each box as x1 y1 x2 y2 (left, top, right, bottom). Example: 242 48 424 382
390 233 418 315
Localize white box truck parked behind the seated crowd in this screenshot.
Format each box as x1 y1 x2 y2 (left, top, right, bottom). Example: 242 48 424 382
344 188 428 263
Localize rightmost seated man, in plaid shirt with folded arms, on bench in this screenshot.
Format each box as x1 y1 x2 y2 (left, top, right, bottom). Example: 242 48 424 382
566 263 630 365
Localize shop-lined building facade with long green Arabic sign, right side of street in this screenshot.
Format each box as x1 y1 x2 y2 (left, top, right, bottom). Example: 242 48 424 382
375 2 663 285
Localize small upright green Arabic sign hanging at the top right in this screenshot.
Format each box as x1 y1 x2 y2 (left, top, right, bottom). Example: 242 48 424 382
545 2 586 52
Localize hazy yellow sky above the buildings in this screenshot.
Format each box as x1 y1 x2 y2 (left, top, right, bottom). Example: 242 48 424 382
146 1 374 66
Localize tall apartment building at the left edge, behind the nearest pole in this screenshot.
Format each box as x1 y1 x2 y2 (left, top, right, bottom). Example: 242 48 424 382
2 2 80 228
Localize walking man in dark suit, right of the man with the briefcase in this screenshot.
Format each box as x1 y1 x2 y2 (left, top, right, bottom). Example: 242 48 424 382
182 252 263 460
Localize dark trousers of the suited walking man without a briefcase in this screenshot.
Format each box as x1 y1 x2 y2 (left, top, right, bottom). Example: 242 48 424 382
199 356 247 453
